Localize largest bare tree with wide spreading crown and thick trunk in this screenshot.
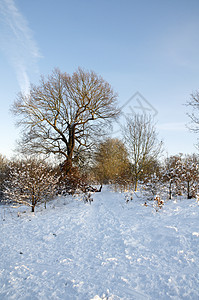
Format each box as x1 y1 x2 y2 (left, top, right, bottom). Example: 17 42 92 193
12 68 119 174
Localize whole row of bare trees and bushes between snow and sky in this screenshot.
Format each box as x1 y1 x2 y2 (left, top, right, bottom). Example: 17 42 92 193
0 68 199 211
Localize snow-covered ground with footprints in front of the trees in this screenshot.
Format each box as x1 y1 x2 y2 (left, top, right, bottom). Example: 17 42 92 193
0 187 199 300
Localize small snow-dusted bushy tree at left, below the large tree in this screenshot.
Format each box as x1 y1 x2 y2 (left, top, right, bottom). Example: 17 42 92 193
5 159 58 212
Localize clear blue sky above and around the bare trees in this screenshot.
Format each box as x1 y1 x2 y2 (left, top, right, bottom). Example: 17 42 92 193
0 0 199 157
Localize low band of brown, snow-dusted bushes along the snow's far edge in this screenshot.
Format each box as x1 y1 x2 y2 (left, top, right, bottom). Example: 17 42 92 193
0 142 199 212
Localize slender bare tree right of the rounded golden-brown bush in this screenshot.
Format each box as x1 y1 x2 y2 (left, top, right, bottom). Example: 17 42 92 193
122 114 162 191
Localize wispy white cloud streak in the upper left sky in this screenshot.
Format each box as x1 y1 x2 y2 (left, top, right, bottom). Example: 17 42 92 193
0 0 41 93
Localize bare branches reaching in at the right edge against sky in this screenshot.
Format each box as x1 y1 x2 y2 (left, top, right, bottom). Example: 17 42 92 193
187 91 199 149
